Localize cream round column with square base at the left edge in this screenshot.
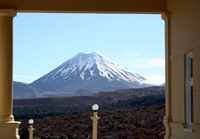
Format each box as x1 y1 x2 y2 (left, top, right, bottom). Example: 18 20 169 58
0 9 20 139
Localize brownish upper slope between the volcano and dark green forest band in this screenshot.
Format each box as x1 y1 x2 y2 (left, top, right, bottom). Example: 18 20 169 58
13 87 165 107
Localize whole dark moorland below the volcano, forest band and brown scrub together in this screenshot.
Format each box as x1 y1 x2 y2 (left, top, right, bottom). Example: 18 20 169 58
14 87 165 139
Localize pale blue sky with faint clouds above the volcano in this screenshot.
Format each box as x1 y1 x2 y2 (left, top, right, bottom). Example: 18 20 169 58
13 13 165 84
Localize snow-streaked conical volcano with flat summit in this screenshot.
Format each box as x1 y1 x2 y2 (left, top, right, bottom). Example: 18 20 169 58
30 52 148 95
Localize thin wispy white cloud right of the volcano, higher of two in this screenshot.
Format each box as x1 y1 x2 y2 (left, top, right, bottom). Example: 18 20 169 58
133 58 165 68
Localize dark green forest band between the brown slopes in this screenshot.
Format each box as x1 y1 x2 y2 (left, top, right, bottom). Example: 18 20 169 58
14 95 165 119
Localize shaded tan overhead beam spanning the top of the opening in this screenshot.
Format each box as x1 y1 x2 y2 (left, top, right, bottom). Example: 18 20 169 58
0 0 167 13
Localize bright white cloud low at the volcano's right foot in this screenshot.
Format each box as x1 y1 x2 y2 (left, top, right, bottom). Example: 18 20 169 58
145 74 165 85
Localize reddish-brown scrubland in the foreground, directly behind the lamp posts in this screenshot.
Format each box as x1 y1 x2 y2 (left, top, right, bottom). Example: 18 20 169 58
20 105 165 139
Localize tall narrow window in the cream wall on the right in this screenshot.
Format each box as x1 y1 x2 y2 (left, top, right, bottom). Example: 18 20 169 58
185 52 193 128
